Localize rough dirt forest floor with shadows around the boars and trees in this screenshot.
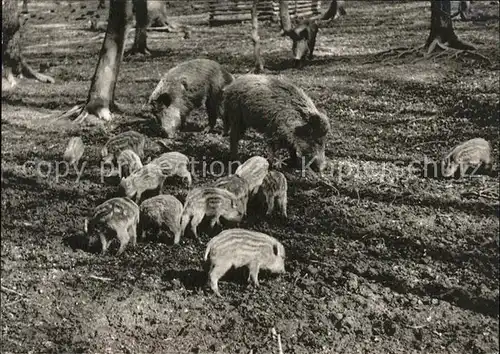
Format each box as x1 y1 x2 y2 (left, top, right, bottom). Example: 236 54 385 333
1 1 499 354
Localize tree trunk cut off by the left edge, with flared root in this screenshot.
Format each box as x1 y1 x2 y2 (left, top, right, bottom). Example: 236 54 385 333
2 0 54 89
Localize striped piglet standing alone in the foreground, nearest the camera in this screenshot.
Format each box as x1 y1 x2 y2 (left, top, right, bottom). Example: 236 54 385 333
203 229 285 296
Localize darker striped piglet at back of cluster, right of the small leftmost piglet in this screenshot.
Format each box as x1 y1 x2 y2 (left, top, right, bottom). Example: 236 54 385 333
101 130 146 163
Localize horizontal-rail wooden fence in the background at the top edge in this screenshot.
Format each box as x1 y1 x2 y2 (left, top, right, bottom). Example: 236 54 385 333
193 0 321 26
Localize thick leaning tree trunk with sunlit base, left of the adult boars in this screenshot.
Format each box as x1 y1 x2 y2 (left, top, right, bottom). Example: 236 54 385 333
85 0 133 120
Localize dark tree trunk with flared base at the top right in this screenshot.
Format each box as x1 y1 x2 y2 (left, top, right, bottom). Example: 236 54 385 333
425 0 476 53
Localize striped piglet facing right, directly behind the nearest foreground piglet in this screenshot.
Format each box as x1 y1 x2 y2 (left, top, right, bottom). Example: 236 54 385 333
181 187 245 239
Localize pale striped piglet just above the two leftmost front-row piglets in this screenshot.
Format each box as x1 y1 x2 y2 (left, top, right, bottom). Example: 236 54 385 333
120 164 166 204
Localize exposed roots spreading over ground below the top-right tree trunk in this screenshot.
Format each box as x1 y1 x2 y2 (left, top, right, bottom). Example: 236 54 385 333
364 39 493 67
